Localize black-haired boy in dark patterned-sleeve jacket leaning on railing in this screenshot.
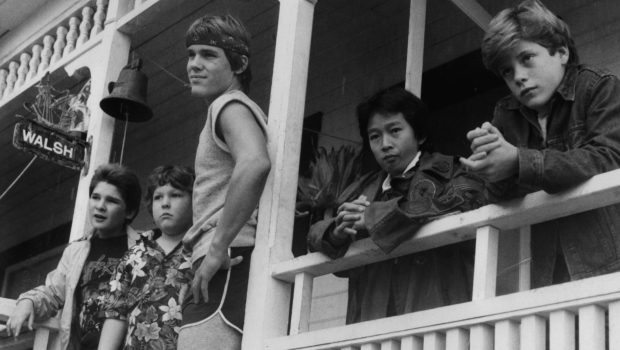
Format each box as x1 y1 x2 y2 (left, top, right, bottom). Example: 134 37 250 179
309 89 483 323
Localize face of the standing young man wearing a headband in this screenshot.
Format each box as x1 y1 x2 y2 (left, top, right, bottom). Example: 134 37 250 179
187 45 241 101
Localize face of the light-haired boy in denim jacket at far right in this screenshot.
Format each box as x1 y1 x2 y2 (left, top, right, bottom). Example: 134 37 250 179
500 40 569 112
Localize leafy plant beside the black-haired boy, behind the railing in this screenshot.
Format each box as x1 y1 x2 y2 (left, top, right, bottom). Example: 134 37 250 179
297 145 361 222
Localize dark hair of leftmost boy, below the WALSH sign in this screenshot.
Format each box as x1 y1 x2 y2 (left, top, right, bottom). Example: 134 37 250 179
88 164 142 224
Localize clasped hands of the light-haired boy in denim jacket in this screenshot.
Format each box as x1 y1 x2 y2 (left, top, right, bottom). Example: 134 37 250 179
459 122 519 182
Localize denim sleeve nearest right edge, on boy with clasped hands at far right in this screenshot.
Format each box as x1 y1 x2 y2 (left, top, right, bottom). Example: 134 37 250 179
518 75 620 193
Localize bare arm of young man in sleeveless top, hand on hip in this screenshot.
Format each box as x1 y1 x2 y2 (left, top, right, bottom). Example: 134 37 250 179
192 102 271 301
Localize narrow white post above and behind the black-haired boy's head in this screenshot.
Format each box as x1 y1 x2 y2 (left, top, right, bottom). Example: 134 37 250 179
405 0 426 96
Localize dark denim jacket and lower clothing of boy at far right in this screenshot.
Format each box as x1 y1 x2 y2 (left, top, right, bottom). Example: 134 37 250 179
488 65 620 287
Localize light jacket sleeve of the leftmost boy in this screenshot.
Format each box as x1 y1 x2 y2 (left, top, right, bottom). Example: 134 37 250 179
17 245 73 322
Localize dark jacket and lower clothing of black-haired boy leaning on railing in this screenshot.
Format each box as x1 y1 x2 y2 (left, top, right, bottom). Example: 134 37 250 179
308 153 484 323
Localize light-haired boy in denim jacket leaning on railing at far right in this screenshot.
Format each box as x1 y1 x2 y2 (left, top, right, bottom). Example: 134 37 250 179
461 0 620 288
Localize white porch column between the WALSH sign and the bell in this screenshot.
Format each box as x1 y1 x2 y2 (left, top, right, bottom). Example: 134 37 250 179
69 0 131 240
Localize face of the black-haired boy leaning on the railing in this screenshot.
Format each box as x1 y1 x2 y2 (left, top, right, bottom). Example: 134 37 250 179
368 112 420 176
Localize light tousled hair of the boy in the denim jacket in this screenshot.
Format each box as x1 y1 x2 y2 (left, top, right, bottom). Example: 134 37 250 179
481 0 579 76
